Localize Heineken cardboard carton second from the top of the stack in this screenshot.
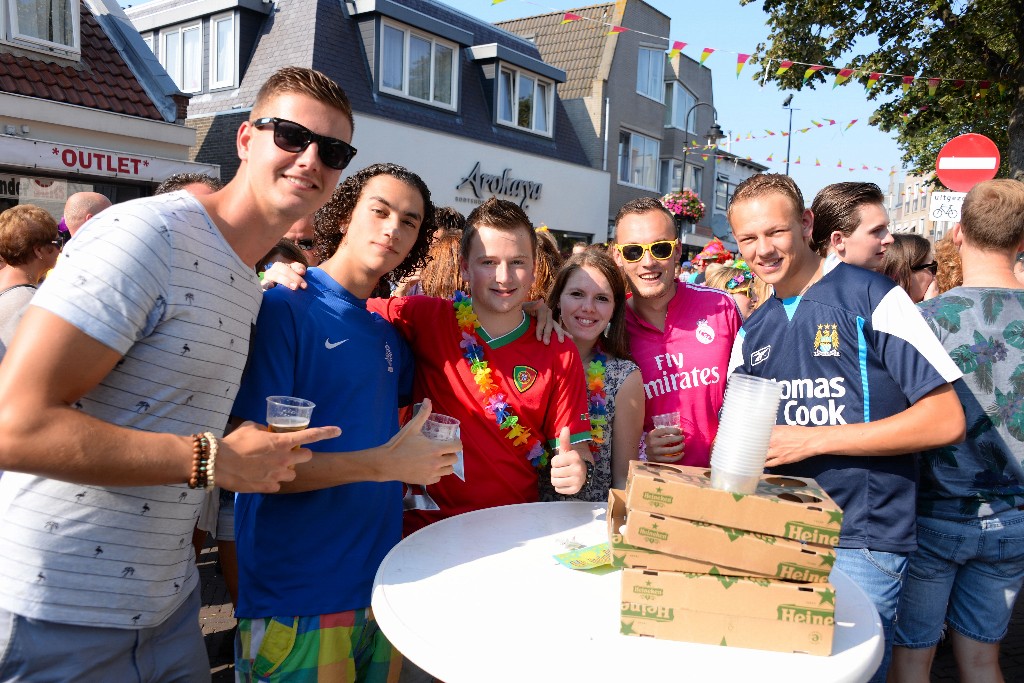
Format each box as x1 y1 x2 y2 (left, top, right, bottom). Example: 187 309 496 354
624 509 836 583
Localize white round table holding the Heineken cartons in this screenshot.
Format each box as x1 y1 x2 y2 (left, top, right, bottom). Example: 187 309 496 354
373 503 883 683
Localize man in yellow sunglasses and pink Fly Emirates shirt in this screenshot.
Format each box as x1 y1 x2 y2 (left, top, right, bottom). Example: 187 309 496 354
614 198 742 467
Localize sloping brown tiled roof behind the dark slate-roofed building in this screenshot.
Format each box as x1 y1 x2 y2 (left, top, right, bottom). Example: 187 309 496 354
495 3 615 99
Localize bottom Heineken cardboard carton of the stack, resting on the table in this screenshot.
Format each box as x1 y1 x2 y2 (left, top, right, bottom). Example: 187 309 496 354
620 568 836 656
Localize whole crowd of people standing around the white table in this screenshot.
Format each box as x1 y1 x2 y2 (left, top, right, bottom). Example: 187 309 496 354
0 68 1024 682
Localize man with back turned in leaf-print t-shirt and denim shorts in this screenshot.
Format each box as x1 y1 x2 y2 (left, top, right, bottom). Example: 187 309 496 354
891 180 1024 681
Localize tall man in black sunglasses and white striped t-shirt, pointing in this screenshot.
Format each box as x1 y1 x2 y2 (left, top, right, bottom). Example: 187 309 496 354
0 68 353 681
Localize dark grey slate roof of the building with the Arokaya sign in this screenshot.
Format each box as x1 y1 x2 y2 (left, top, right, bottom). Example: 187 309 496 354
180 0 589 166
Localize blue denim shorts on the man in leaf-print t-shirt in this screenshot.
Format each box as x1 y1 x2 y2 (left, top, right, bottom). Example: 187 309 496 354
896 510 1024 648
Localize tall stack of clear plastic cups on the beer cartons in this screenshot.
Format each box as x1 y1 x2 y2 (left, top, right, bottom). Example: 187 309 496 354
711 375 781 494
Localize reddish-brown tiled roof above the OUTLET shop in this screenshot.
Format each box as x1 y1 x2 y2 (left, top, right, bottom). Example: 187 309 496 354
0 2 164 121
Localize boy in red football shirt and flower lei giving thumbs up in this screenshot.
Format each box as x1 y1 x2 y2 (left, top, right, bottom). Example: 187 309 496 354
369 198 593 535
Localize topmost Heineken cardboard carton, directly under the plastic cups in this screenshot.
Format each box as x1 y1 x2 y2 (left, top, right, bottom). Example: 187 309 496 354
626 461 843 548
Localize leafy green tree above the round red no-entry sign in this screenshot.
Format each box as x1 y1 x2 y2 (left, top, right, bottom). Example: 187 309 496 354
740 0 1024 180
